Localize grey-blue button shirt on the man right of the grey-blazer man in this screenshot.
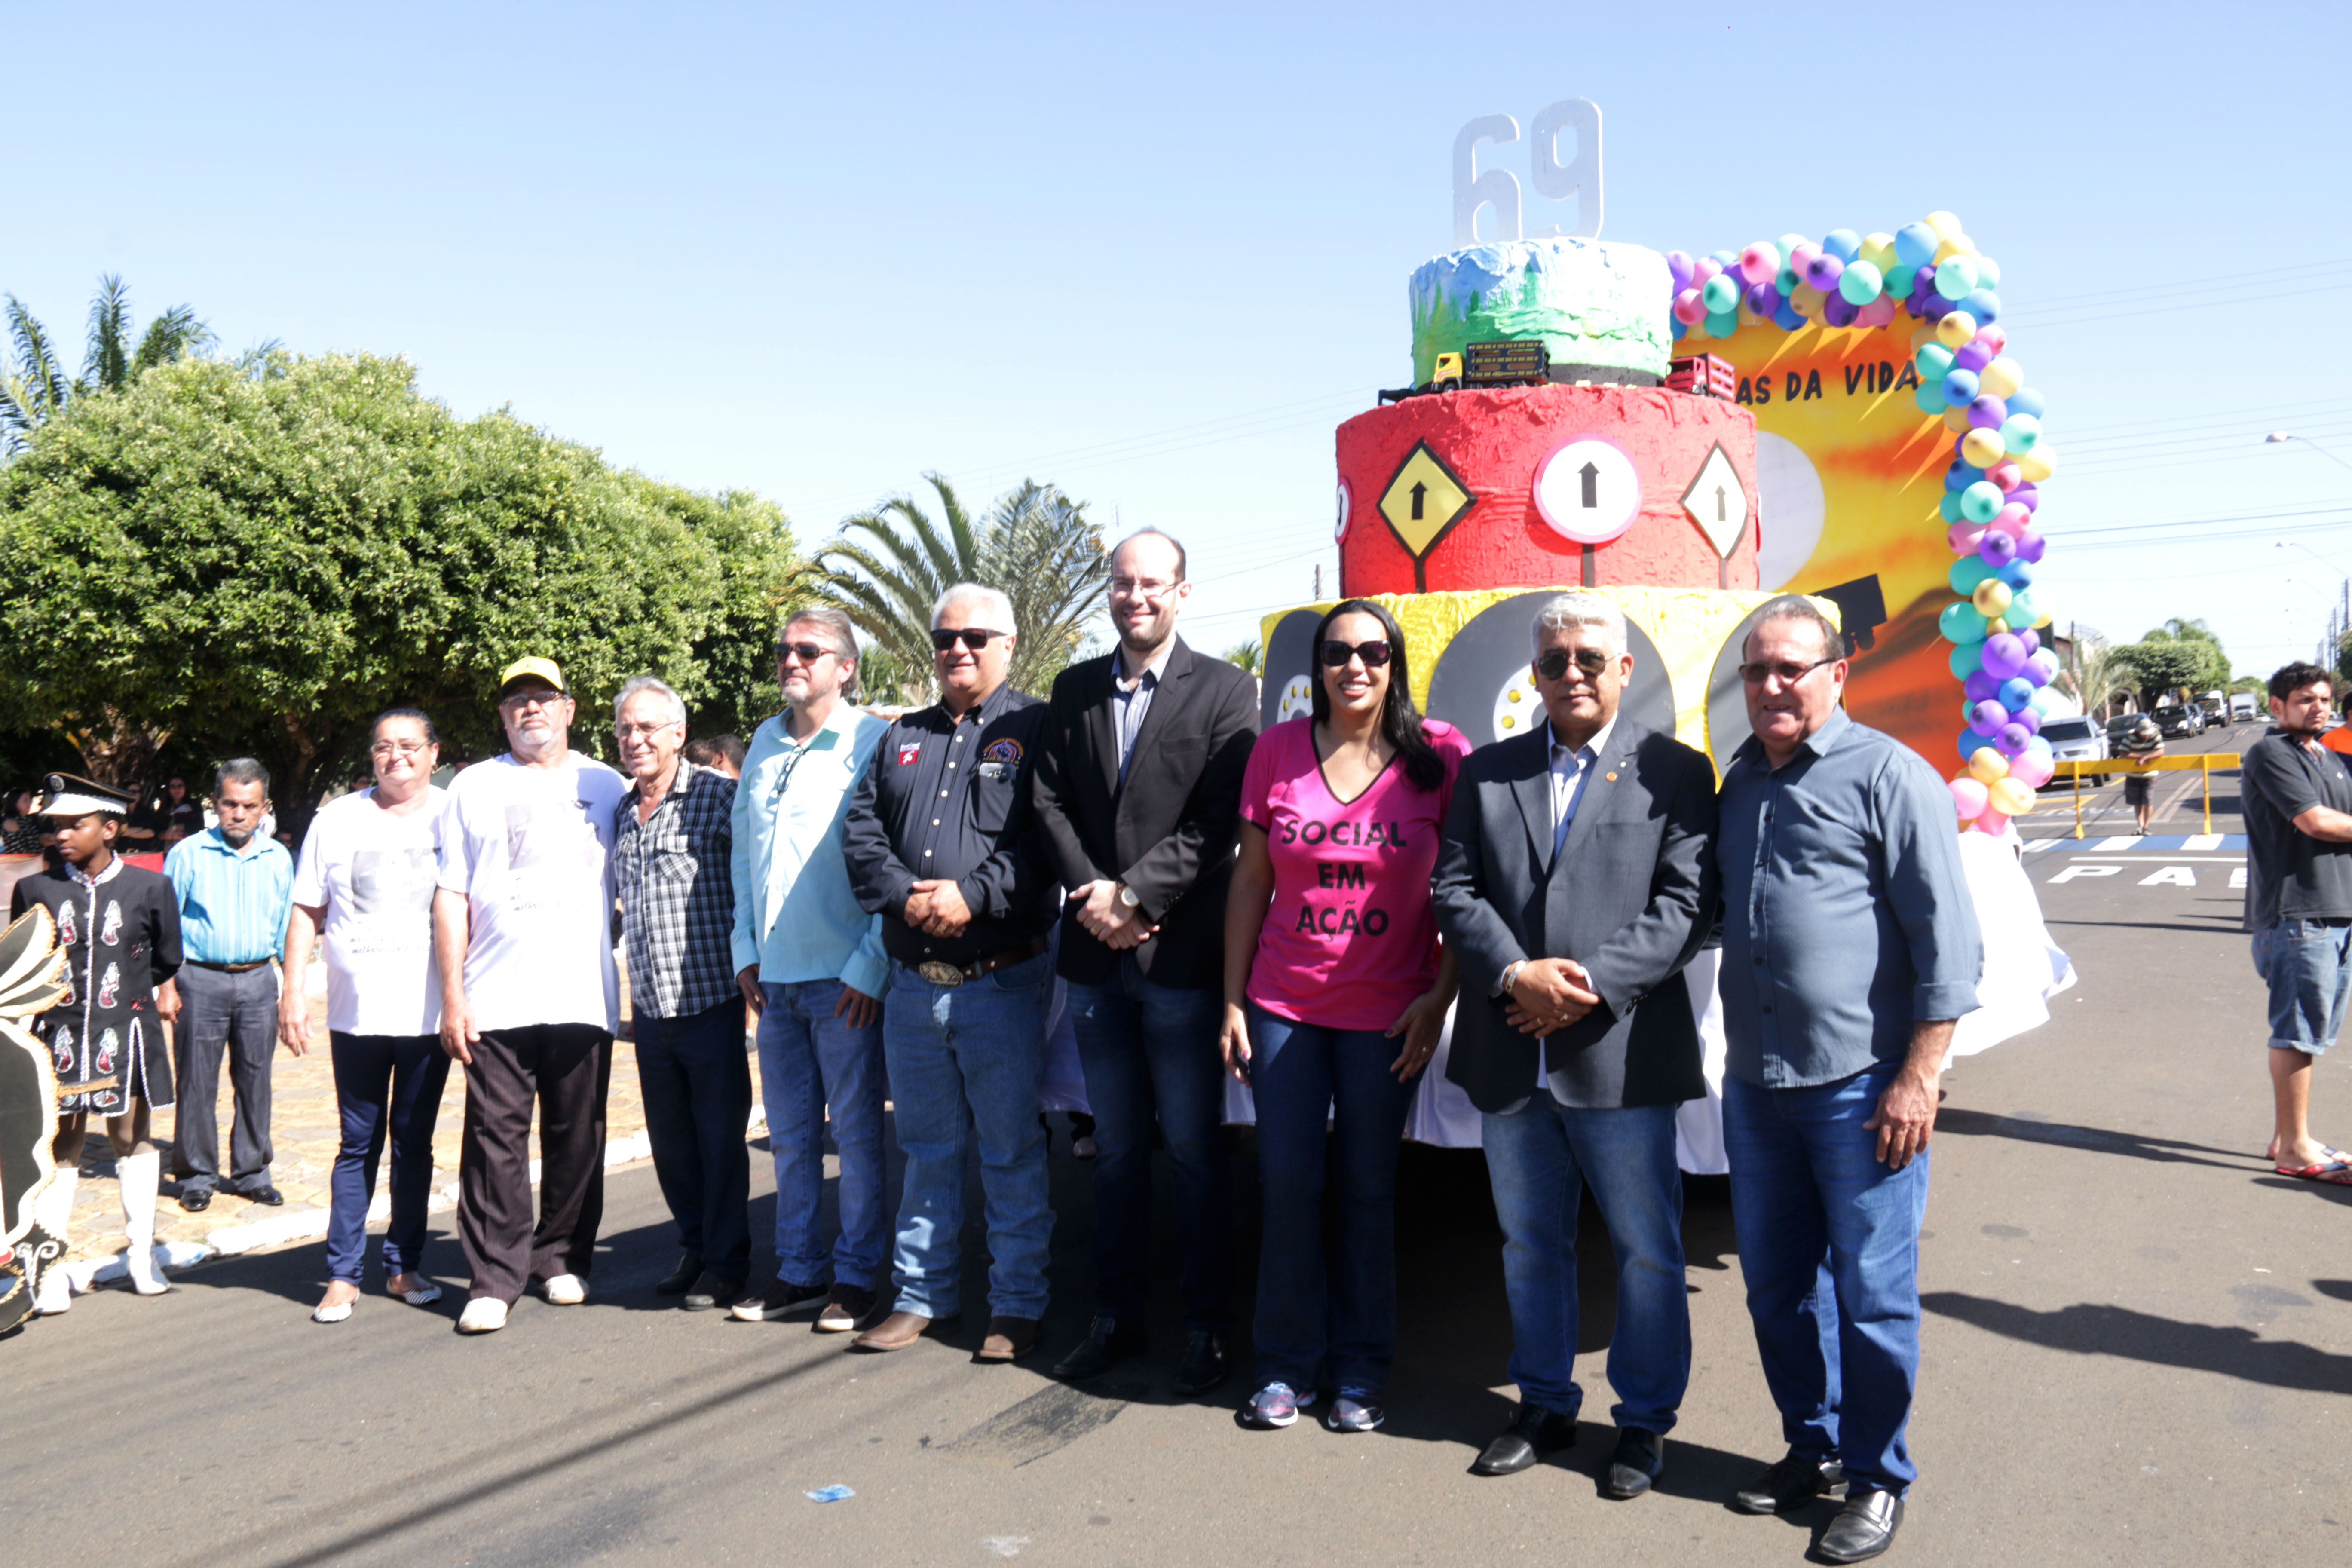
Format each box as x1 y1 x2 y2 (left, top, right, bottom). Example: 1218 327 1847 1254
1715 710 1983 1088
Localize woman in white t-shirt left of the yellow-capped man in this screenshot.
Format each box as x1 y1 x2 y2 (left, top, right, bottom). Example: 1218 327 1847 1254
278 707 449 1323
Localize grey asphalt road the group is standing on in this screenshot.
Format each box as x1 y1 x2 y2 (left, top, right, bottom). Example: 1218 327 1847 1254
0 729 2352 1568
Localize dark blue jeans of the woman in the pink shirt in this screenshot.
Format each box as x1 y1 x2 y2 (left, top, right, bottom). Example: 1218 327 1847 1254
1249 1004 1414 1392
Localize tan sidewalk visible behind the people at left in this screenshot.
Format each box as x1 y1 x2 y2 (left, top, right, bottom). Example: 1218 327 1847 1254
66 971 764 1288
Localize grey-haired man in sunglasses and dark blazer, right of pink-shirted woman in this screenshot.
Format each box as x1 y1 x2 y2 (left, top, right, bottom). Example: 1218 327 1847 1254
1435 592 1715 1498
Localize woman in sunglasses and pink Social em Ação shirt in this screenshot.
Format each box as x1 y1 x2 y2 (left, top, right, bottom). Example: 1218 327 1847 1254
1221 600 1470 1432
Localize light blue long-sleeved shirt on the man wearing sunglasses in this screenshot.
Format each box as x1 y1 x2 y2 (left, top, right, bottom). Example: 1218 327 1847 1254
734 703 889 997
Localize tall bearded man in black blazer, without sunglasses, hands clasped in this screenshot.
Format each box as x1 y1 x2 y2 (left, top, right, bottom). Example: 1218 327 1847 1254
1035 531 1259 1394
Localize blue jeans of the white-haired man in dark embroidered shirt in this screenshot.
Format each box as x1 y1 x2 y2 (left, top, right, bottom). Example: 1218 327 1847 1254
882 955 1054 1319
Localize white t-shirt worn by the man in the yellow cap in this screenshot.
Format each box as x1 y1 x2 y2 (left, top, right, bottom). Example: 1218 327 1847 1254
440 752 628 1030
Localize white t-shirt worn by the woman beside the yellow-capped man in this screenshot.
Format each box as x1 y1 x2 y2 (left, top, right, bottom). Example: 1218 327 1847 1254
294 787 449 1034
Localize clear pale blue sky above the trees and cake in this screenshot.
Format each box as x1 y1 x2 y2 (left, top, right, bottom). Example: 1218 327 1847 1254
0 2 2352 672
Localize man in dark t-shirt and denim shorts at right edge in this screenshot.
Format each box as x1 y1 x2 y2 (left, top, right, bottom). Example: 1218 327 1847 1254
2239 663 2352 1187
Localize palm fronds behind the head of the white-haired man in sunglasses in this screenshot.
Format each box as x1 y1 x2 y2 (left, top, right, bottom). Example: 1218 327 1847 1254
816 472 1110 696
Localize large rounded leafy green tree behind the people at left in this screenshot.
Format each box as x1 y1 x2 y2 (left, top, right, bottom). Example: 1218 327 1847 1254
0 352 797 830
